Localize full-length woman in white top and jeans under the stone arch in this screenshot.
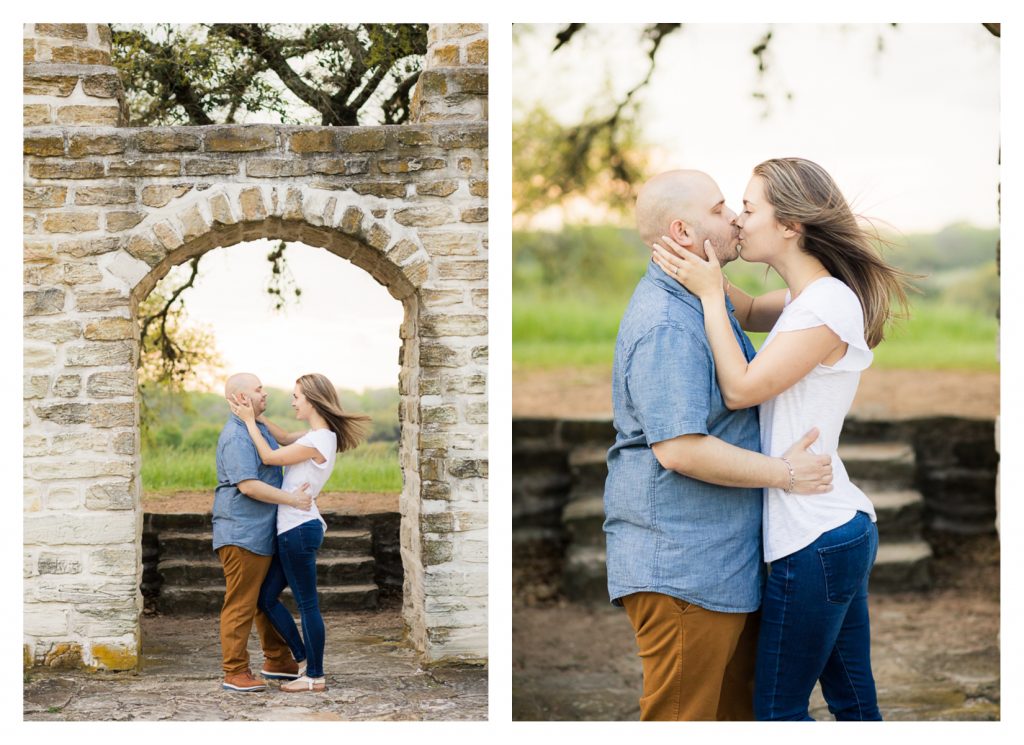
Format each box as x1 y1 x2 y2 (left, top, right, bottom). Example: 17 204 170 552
229 374 370 693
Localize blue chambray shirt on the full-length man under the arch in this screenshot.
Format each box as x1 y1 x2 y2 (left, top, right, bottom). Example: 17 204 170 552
213 414 284 556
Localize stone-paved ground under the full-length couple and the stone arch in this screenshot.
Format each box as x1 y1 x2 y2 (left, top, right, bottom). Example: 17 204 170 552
25 601 487 721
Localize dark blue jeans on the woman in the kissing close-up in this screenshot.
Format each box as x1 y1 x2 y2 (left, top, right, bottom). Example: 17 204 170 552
754 512 882 721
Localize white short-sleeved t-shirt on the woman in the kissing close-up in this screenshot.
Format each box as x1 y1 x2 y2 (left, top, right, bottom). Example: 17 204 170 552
761 276 876 562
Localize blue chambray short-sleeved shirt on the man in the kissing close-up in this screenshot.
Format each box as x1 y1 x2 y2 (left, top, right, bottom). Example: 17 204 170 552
604 262 763 613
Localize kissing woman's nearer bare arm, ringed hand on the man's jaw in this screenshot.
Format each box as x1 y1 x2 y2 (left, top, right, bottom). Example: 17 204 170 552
654 237 843 409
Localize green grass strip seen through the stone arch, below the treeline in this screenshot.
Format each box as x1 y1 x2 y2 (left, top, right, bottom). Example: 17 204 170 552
142 442 401 493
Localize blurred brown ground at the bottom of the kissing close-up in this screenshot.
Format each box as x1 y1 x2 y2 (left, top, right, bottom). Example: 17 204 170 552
512 536 999 721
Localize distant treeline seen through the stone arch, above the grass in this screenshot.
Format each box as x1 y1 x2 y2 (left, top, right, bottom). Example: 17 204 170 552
142 386 400 450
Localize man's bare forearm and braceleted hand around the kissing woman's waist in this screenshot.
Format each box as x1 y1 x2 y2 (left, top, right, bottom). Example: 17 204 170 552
651 430 833 494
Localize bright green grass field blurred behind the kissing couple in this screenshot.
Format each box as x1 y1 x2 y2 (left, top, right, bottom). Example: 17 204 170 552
512 293 998 370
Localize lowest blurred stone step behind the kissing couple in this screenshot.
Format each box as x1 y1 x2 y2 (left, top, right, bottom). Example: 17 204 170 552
562 540 932 603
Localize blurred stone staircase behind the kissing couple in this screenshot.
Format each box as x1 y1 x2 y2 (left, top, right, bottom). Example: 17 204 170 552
562 438 932 603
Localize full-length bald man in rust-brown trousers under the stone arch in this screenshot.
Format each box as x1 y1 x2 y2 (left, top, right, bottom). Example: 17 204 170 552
213 373 312 692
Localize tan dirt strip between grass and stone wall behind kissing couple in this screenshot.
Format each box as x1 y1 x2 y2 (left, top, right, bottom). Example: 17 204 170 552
512 367 999 419
